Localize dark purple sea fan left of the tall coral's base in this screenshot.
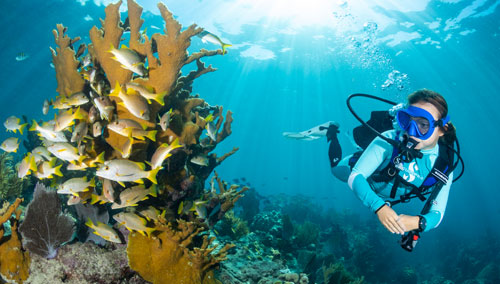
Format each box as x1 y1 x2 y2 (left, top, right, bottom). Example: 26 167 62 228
19 183 75 258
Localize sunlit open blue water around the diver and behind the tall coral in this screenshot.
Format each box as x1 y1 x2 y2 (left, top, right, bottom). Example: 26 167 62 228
0 0 500 282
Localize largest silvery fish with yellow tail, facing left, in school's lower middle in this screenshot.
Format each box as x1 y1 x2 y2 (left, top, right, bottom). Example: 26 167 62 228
96 159 160 187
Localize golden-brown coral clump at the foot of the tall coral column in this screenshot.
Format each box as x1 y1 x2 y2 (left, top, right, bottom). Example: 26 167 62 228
127 218 234 284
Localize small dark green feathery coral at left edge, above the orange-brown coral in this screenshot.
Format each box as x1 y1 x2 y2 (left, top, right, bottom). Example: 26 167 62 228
0 153 30 200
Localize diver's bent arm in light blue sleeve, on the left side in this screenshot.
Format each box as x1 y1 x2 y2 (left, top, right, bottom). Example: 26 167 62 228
348 131 392 212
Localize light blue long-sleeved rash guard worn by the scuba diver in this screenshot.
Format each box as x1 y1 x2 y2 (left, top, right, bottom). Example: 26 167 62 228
332 130 453 231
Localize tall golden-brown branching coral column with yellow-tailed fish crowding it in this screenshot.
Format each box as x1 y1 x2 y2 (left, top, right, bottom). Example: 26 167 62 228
15 0 240 283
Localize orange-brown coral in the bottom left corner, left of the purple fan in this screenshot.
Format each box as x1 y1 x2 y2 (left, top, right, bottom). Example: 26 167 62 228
0 198 31 283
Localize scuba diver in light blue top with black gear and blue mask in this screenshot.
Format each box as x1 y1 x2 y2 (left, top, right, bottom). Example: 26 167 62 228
326 89 463 251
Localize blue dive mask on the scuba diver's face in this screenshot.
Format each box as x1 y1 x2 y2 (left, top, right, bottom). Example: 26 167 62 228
396 106 450 140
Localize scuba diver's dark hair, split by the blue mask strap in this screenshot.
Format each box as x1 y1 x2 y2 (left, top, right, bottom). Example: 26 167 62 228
408 89 457 145
